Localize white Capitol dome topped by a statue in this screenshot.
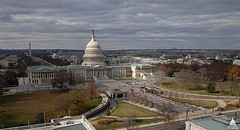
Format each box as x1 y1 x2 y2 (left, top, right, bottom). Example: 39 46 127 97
82 30 105 66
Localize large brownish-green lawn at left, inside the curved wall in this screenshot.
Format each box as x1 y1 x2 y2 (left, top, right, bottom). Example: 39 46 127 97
0 90 101 128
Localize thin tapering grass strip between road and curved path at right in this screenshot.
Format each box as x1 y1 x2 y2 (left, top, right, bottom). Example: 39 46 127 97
174 99 218 109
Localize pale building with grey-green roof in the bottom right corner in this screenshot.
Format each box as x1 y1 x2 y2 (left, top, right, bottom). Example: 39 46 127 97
185 116 240 130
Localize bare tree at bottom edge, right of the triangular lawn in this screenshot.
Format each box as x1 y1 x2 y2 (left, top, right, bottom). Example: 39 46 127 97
156 102 179 130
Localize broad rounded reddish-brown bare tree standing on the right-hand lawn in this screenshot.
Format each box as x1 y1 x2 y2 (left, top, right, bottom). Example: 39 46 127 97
175 69 196 89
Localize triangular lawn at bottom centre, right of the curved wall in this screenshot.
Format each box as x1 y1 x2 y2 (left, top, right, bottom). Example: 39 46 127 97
111 101 159 117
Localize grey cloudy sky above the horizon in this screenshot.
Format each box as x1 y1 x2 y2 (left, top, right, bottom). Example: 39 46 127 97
0 0 240 50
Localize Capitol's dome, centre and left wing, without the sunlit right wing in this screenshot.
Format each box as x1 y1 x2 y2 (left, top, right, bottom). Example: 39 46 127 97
27 30 126 84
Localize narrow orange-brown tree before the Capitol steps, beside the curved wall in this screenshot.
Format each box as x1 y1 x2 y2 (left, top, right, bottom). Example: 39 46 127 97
87 79 99 100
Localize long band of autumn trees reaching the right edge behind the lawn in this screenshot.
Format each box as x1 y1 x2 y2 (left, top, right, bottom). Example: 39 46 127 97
157 62 240 96
